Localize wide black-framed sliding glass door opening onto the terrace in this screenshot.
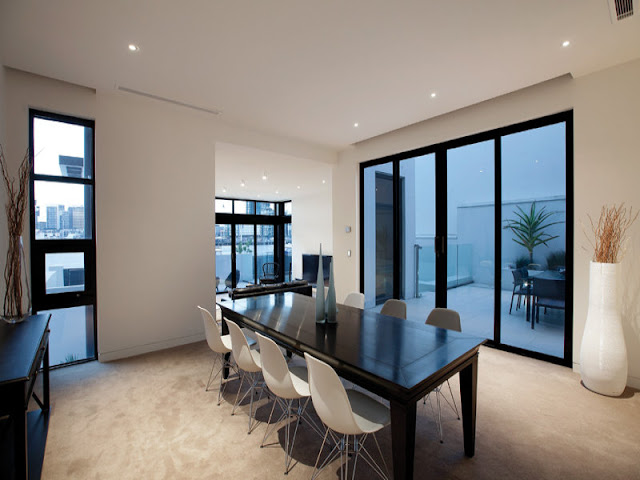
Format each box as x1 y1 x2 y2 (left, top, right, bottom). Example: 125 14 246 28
360 112 573 365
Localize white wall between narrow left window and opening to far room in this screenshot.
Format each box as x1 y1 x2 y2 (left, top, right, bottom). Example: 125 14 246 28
0 69 335 361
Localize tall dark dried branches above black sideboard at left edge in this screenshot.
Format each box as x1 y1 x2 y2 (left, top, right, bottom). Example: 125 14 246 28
0 145 31 318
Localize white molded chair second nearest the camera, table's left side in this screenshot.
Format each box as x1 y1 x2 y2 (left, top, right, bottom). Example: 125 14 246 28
256 333 322 475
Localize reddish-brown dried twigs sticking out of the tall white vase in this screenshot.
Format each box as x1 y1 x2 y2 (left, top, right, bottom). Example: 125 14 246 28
585 203 639 263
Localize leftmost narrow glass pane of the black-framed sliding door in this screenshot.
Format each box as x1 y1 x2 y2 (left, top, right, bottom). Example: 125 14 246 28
363 162 394 308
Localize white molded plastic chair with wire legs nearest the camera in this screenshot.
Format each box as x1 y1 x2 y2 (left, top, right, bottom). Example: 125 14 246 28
304 353 391 480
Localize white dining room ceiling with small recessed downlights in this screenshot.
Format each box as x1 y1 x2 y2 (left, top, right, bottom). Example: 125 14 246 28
0 0 640 199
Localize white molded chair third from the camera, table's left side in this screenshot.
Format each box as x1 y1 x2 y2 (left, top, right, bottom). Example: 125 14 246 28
225 320 262 433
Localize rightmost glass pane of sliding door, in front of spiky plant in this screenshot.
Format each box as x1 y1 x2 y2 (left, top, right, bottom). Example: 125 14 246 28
501 122 567 358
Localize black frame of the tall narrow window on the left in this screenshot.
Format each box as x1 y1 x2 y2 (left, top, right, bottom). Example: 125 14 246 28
29 109 98 365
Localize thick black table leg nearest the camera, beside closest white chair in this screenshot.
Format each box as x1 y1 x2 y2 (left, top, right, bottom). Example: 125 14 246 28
391 401 416 480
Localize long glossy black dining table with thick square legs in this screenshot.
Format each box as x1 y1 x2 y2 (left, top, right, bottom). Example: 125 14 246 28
218 292 486 480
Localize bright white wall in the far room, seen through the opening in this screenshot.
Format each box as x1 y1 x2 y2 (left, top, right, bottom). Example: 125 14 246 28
291 185 336 278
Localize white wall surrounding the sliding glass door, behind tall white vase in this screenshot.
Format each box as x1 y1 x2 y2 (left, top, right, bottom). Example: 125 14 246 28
333 60 640 387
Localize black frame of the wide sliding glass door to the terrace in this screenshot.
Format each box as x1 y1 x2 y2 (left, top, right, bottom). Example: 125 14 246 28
359 110 574 366
